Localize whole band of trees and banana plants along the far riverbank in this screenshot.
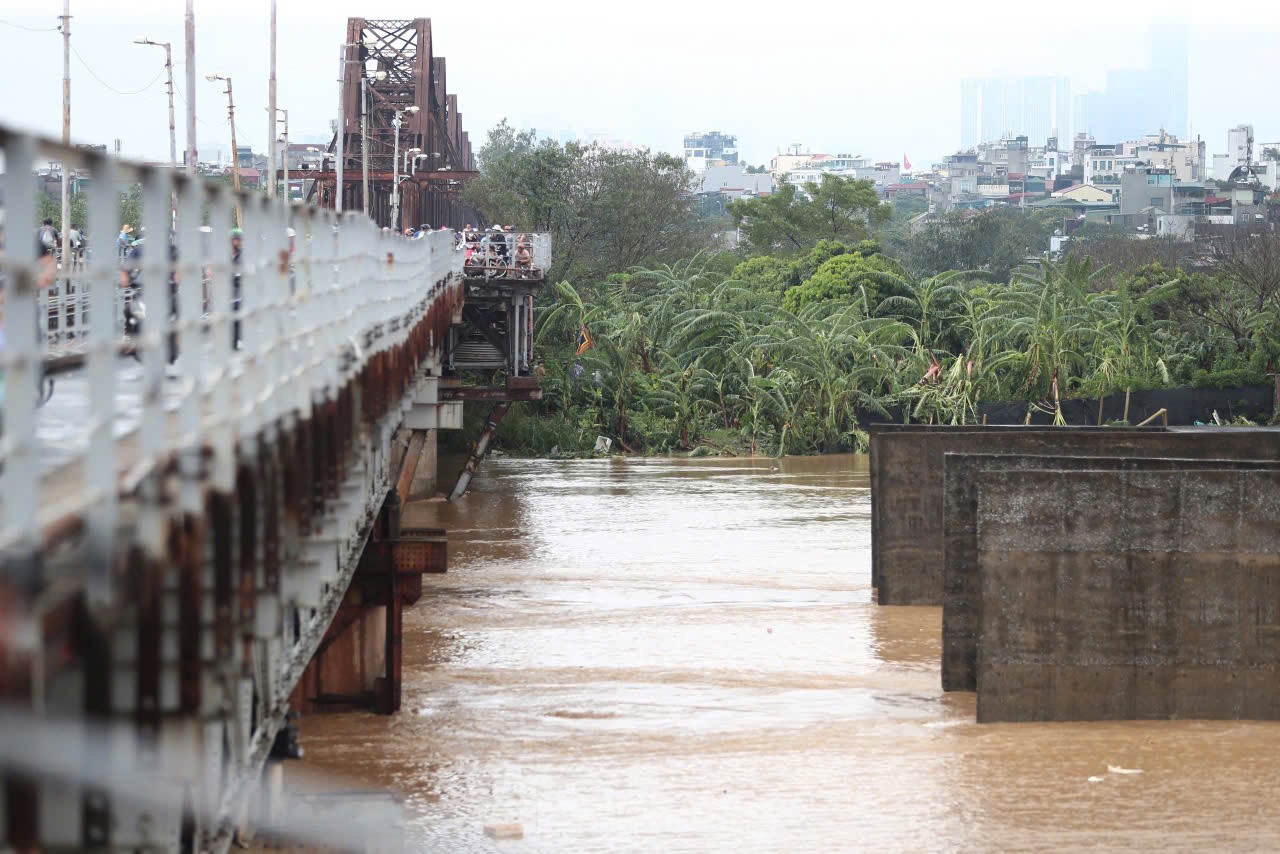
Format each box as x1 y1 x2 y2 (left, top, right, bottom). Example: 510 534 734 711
470 128 1280 455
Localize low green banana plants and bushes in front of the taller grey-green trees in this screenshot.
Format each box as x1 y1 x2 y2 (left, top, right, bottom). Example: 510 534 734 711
499 211 1280 455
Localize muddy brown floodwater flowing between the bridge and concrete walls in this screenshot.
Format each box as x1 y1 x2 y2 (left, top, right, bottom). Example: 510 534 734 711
294 456 1280 851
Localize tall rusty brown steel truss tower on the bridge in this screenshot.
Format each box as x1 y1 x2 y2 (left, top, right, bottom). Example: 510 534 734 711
311 18 476 230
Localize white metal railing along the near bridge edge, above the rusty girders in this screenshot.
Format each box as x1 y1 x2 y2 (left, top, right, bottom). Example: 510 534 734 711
0 120 461 563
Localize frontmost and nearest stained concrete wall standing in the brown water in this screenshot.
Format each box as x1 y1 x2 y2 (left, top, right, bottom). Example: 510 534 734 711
977 470 1280 722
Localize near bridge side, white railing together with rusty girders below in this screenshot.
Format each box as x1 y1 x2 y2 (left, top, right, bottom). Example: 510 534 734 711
0 125 462 850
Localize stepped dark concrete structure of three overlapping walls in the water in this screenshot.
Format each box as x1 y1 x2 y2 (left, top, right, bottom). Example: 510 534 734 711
872 425 1280 722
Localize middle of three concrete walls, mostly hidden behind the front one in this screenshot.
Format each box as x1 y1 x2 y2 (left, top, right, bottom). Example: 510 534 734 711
942 453 1280 691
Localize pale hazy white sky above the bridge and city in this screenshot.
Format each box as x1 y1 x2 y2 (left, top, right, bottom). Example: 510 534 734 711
0 0 1280 166
